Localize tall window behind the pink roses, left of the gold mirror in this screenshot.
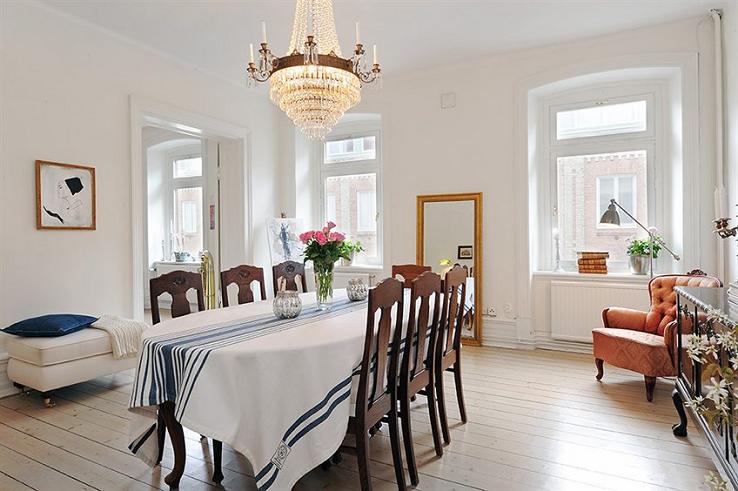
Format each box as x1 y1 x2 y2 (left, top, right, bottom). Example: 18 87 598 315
320 131 382 265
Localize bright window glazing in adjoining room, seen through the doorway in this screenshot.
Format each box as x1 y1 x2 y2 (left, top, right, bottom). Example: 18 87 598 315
169 155 205 258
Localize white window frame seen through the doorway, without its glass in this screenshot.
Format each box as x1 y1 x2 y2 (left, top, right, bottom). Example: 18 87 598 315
164 145 208 262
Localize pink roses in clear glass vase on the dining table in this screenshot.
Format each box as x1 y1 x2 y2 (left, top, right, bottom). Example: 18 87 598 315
300 222 348 310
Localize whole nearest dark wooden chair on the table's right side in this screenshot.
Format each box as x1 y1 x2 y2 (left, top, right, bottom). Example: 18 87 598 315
340 278 405 491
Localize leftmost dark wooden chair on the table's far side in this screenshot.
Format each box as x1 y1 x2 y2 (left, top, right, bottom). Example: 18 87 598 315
149 271 223 482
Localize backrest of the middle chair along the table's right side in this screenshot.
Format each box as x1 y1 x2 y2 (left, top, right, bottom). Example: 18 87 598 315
400 271 441 383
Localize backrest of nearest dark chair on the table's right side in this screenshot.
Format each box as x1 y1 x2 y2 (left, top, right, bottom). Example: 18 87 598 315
356 278 403 421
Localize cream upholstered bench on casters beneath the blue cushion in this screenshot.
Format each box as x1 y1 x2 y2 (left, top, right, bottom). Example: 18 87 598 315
5 328 137 407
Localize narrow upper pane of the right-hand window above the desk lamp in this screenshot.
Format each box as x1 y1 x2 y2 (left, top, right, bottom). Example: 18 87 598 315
556 101 647 140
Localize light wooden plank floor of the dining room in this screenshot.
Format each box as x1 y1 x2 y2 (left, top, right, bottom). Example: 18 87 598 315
0 348 713 491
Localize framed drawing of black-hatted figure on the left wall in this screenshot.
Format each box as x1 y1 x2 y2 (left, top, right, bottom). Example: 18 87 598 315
36 160 96 230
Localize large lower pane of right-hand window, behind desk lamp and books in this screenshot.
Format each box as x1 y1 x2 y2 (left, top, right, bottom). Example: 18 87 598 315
556 150 648 263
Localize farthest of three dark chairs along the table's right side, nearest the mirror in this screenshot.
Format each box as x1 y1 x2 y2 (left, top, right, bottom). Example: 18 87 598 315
434 266 467 444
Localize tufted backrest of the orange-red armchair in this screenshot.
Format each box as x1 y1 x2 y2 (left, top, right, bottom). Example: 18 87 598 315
646 270 722 335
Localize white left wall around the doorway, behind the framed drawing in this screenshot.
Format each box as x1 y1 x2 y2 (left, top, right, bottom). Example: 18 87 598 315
0 2 278 357
